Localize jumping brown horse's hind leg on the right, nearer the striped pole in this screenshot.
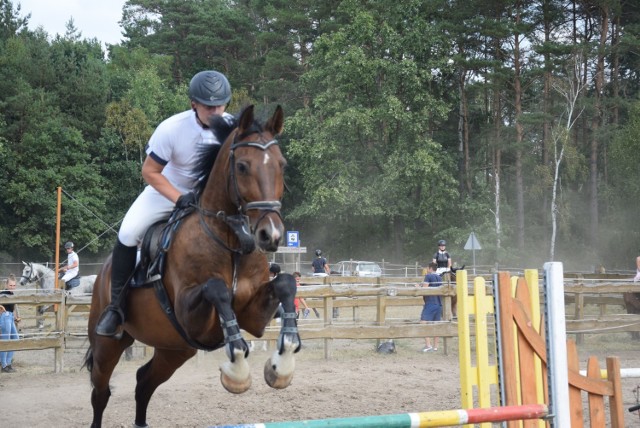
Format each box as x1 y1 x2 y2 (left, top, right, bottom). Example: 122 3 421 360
135 348 196 427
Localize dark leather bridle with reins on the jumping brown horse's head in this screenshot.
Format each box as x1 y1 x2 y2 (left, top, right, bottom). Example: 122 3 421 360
197 135 282 255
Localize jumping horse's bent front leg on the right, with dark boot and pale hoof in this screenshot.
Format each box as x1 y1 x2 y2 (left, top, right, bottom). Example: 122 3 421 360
264 274 301 389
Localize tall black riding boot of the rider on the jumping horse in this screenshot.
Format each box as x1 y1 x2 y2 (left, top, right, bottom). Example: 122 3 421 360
96 240 138 336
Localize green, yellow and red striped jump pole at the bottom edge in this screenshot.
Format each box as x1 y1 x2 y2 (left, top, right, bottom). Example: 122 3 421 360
210 404 548 428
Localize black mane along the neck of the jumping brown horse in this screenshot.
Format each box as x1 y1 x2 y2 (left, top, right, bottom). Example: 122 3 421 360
193 107 262 194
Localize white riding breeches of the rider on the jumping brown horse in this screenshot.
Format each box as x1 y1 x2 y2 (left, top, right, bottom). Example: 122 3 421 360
118 186 182 247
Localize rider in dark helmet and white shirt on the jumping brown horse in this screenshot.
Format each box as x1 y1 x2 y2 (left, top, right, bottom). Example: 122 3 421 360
96 70 233 336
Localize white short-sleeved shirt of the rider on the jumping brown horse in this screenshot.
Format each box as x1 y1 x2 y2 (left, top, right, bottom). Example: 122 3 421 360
146 110 233 192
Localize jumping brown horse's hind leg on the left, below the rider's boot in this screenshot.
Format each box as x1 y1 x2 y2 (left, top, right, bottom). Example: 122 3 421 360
89 334 133 428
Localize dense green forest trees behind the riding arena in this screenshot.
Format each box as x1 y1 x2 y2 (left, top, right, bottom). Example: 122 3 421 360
0 0 640 267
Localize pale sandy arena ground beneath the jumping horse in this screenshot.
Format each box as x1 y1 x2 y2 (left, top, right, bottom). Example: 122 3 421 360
0 334 640 427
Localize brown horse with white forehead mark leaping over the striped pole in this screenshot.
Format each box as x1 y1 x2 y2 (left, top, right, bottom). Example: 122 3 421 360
85 106 300 427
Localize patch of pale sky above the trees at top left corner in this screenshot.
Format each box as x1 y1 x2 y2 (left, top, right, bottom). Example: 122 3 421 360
13 0 126 44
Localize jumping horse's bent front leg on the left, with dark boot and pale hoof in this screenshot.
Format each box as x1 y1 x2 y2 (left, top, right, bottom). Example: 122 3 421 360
202 278 251 394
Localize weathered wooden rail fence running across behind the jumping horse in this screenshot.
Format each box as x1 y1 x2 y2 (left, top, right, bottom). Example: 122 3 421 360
0 277 640 372
